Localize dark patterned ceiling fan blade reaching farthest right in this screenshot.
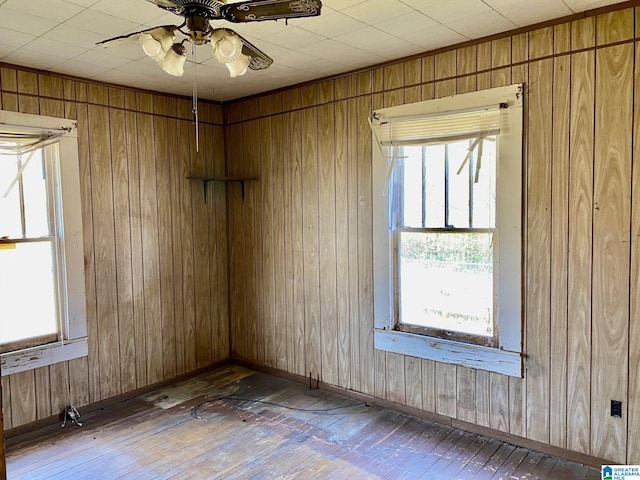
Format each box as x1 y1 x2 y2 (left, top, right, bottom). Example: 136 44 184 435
220 0 322 23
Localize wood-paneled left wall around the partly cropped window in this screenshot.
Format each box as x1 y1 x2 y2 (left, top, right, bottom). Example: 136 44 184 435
0 66 229 429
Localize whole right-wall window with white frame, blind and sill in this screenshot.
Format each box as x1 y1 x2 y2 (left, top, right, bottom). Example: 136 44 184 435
372 85 523 376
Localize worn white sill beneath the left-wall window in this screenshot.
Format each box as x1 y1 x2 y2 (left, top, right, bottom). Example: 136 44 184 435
0 337 88 377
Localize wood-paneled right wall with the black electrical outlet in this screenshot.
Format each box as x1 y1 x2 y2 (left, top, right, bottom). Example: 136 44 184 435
225 8 640 463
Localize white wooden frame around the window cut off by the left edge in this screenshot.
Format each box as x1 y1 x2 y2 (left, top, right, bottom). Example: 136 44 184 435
0 110 88 376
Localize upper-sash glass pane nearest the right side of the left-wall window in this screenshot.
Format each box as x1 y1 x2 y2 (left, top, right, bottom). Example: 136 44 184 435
22 150 50 238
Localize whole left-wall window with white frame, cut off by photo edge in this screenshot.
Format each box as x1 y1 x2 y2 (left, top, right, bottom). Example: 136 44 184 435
0 111 87 375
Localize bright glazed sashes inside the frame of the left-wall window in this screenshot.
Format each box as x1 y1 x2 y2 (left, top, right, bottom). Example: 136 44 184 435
0 145 62 352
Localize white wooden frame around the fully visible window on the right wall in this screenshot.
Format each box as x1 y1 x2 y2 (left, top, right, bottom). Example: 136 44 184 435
372 84 524 377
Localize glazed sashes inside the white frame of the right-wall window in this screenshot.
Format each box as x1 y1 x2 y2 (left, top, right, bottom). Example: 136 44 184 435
392 139 496 345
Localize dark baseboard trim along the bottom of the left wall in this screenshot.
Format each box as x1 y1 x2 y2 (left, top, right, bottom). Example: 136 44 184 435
4 359 230 439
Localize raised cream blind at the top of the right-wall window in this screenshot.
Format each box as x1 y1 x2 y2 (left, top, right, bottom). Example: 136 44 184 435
371 105 503 146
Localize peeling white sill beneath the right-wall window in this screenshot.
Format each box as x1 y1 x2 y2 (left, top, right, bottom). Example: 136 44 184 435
374 329 522 377
